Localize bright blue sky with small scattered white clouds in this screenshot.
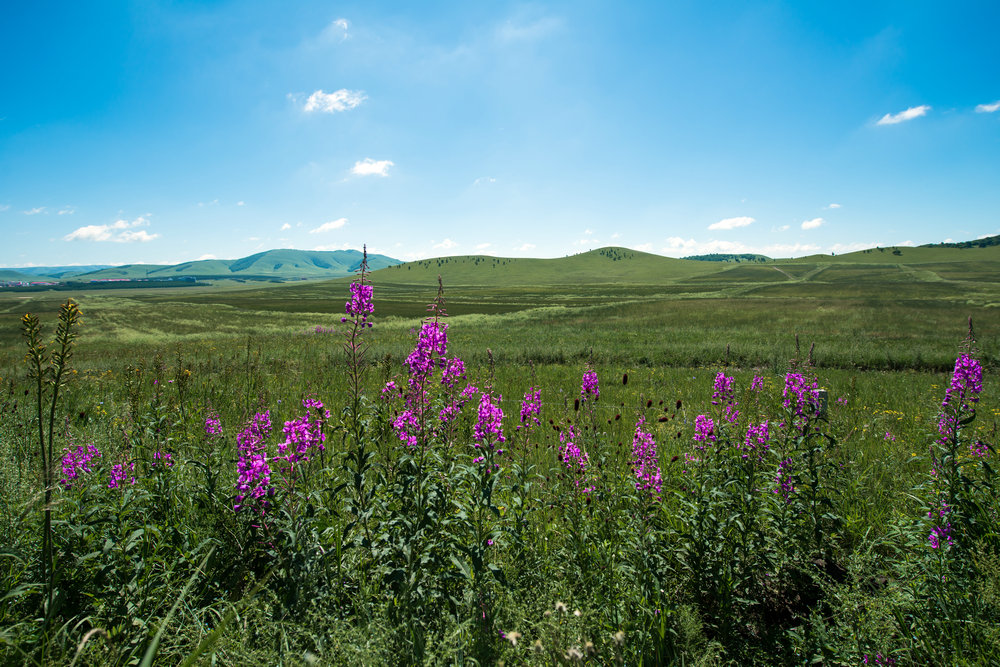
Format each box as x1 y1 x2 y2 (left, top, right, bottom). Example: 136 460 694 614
0 0 1000 266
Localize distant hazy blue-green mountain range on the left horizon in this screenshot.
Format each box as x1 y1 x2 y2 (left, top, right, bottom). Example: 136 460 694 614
0 250 400 282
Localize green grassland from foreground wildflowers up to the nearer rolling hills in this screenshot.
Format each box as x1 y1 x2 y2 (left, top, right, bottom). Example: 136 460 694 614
0 248 1000 664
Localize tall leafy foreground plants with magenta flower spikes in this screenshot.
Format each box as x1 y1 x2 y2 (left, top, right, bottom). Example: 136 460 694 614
0 276 1000 664
